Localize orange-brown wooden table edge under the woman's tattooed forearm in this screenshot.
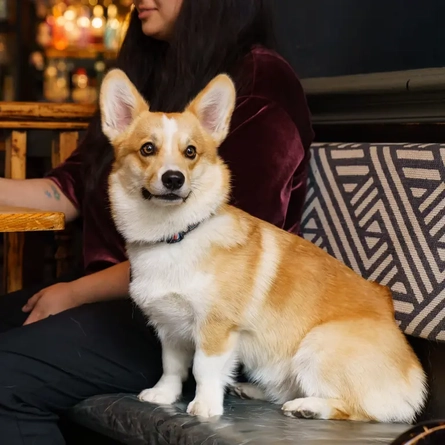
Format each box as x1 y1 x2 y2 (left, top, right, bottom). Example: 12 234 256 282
0 206 65 232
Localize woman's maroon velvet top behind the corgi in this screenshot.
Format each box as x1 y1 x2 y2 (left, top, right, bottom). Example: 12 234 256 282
47 48 313 273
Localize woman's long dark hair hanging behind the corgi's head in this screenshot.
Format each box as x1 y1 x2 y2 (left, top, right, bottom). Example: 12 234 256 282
81 0 275 190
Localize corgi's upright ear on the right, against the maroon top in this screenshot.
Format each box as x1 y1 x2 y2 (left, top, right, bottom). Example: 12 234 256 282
187 74 236 144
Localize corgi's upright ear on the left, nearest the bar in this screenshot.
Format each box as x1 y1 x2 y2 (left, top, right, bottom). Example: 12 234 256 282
99 69 149 142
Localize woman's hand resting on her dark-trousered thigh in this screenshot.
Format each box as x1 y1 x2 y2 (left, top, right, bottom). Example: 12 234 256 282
22 283 80 325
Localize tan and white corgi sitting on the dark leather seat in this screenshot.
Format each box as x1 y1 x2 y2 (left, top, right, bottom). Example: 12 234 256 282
100 69 427 422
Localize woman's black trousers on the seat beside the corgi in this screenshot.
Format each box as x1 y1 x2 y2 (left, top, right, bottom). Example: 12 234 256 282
0 276 162 445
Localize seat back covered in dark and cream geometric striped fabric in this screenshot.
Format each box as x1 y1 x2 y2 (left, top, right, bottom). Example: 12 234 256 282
302 143 445 341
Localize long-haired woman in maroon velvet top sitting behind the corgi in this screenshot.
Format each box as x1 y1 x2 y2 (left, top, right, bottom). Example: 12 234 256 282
0 0 313 445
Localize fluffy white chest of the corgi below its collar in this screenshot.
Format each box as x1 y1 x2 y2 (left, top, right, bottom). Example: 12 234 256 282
128 243 211 338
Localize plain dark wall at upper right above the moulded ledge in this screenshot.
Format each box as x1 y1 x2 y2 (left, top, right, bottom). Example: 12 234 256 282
274 0 445 77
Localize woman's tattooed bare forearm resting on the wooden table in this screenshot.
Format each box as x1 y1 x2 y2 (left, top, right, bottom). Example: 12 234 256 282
0 178 79 221
